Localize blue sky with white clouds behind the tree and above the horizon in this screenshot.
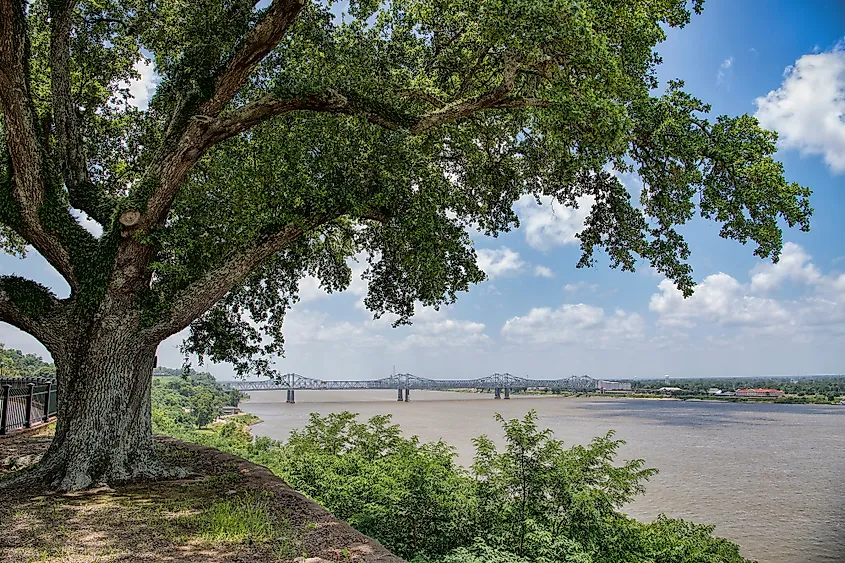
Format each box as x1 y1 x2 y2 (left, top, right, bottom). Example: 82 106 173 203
0 0 845 379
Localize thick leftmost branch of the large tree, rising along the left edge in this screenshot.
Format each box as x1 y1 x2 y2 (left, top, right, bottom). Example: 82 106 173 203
0 0 77 289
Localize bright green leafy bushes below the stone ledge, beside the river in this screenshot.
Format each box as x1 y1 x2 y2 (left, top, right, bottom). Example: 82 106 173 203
168 411 748 563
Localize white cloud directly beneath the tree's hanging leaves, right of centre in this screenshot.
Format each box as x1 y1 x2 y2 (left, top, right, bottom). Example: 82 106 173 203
515 195 595 250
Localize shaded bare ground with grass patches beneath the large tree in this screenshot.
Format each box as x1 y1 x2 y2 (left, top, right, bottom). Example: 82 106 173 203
0 429 403 563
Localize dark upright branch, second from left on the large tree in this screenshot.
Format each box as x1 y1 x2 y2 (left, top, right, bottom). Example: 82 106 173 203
49 0 113 225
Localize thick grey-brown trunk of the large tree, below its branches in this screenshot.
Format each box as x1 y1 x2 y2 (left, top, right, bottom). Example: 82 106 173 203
36 325 181 490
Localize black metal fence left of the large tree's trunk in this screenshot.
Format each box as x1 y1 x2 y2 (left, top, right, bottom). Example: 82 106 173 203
0 378 56 434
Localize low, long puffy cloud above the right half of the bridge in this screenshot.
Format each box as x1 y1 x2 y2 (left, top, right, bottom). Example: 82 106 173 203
501 303 645 347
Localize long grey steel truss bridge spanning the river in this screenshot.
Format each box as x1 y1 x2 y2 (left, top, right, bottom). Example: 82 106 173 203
220 373 598 403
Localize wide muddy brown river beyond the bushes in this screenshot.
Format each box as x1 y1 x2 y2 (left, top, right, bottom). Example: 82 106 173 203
241 390 845 563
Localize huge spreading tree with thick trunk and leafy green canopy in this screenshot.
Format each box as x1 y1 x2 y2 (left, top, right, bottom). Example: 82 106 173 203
0 0 810 489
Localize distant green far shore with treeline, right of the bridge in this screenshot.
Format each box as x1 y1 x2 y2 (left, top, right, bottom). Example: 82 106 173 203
631 375 845 400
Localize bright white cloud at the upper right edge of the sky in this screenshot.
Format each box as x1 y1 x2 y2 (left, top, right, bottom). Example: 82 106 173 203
755 42 845 173
